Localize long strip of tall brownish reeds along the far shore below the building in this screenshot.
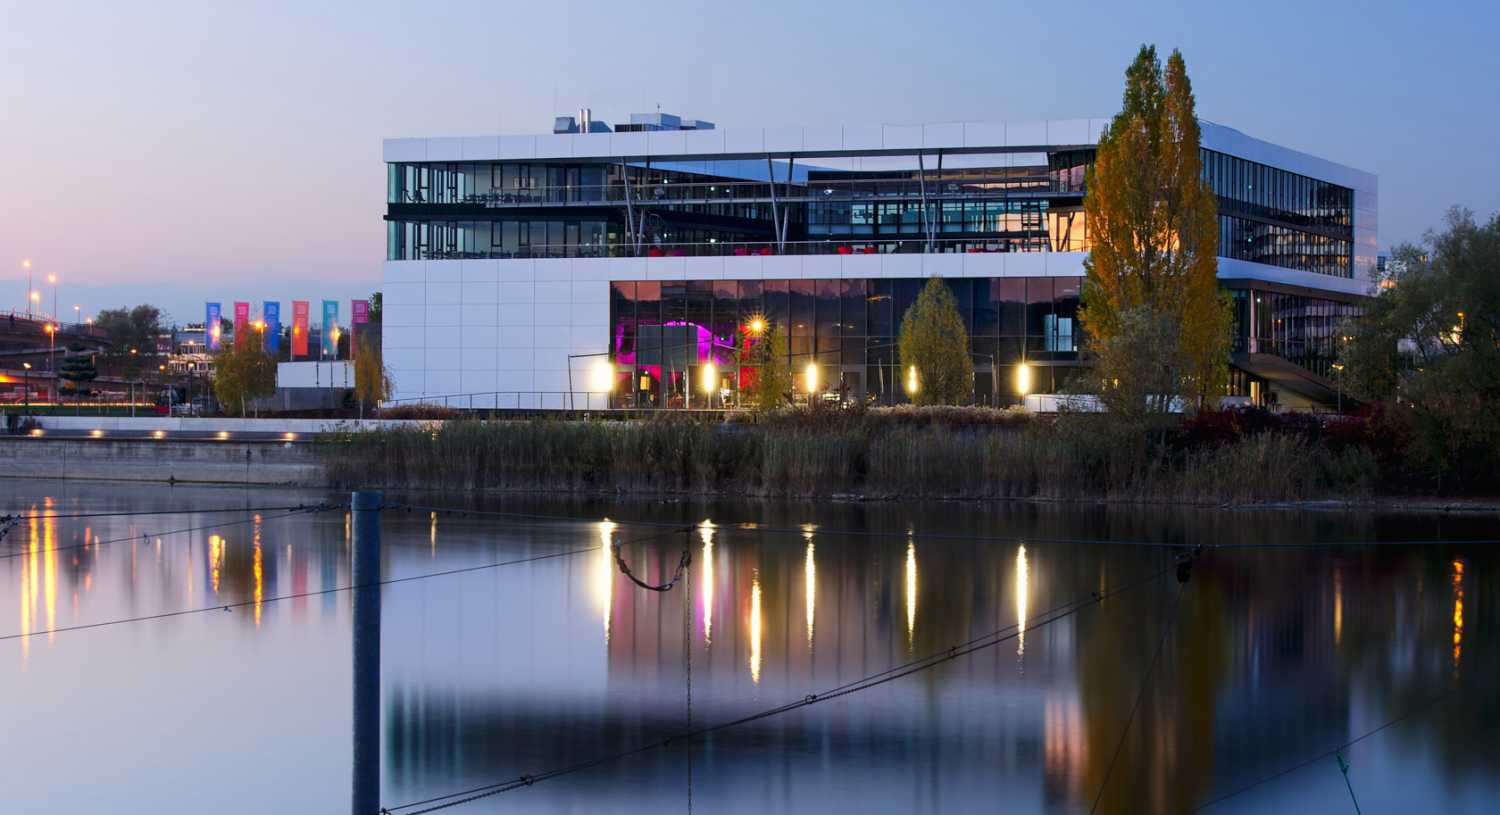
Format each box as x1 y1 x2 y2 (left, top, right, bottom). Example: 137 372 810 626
324 411 1379 503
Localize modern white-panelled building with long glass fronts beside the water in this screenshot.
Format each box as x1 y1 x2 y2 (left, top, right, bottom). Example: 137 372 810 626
384 114 1377 410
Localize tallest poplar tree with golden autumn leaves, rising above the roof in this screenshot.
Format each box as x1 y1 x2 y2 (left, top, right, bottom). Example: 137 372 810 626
1080 45 1232 411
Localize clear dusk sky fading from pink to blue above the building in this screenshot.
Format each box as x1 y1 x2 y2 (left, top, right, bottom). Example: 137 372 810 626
0 0 1500 321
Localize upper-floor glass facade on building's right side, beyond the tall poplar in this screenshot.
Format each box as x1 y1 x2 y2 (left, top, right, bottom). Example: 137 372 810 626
1203 150 1355 278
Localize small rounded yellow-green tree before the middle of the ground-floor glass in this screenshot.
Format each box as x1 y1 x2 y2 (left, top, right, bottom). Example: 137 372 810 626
897 278 974 405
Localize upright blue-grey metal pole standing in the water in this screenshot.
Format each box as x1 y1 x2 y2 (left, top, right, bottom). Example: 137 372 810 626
350 492 383 815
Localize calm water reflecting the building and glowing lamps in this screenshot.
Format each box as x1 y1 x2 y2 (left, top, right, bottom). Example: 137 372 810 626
0 482 1500 813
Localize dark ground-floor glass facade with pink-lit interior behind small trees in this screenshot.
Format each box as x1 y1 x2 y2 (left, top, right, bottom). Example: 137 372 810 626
609 278 1083 408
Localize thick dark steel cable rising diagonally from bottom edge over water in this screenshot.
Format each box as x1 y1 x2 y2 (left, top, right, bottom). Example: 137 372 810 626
381 567 1173 815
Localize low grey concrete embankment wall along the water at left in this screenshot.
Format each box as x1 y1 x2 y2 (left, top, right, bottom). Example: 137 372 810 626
0 437 323 485
